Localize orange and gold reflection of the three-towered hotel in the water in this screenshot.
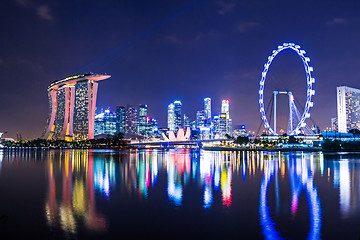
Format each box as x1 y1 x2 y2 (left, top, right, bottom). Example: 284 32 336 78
45 150 108 233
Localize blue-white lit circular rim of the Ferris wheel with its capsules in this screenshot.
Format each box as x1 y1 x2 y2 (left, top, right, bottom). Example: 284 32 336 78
259 43 315 135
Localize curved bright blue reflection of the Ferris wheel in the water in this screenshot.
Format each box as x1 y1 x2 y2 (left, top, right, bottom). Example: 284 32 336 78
259 155 321 239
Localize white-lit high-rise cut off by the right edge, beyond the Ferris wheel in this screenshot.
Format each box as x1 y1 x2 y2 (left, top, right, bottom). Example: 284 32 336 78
336 86 360 133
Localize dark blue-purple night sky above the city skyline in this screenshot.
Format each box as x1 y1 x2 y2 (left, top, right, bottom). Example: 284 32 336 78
0 0 360 139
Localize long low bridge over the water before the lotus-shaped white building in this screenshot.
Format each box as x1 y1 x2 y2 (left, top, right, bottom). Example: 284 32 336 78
128 138 235 148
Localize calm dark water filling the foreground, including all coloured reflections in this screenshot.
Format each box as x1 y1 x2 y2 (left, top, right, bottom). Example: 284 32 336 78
0 149 360 239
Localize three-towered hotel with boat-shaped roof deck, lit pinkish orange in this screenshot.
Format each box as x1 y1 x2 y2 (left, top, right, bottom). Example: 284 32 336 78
43 73 111 141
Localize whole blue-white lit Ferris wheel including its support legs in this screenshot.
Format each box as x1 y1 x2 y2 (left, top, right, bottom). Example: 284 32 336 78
259 43 315 135
